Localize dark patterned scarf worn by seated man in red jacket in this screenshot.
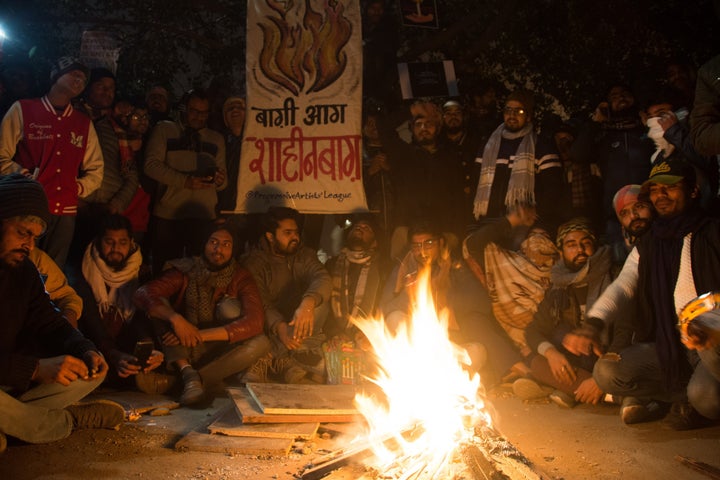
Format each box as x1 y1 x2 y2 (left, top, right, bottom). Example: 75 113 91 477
175 257 236 325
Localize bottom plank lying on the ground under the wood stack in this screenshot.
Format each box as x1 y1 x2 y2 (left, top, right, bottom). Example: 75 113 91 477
175 431 293 456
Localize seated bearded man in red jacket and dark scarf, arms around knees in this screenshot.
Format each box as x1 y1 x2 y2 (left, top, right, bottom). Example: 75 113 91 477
134 226 270 406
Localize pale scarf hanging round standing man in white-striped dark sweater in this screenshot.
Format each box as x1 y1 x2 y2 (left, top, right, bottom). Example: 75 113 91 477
473 122 536 219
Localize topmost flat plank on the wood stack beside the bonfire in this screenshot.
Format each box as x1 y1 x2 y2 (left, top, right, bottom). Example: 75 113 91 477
246 383 358 415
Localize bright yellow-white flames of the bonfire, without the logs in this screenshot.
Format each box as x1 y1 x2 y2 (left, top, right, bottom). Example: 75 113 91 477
355 268 491 478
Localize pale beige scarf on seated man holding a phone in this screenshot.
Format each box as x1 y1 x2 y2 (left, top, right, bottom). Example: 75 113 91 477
82 242 142 335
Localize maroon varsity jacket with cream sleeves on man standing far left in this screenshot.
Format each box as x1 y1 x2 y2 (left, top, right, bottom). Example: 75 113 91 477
0 96 103 215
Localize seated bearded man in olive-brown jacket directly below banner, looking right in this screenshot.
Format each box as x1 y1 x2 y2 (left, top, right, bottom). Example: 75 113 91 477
244 207 332 383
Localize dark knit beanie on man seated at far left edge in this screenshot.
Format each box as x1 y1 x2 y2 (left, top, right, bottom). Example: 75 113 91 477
0 173 50 225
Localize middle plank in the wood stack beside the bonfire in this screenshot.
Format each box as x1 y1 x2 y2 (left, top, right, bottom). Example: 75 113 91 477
208 407 320 440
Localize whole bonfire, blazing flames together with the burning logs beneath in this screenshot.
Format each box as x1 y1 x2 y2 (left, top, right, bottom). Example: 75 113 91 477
302 270 543 480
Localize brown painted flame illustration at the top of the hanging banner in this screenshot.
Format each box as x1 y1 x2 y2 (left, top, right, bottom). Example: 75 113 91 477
258 0 352 96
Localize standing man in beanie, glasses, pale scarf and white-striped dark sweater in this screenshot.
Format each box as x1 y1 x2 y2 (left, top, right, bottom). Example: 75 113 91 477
473 90 563 231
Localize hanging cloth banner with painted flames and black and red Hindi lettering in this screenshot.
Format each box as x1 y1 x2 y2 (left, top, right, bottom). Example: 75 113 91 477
235 0 367 214
